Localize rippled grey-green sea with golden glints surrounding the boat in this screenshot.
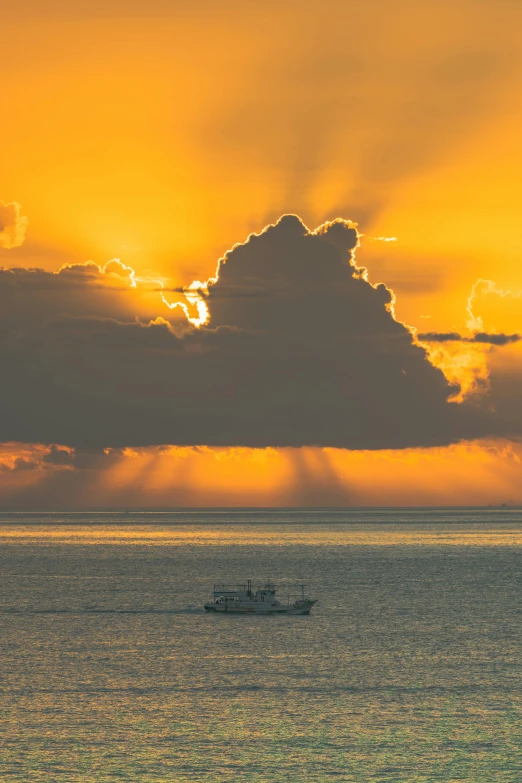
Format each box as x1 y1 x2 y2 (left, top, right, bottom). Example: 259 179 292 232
0 509 522 783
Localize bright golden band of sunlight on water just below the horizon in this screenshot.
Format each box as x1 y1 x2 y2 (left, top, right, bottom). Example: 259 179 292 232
0 524 522 547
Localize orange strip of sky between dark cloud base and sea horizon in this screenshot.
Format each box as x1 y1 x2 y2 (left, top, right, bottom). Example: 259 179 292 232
0 441 522 508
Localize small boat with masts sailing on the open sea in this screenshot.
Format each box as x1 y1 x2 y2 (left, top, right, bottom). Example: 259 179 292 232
204 579 317 614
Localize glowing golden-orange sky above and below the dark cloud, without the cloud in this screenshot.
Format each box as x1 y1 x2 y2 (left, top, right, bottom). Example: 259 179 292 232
0 0 522 506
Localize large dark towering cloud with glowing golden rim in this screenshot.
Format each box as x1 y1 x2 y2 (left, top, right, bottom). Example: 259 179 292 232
0 216 504 450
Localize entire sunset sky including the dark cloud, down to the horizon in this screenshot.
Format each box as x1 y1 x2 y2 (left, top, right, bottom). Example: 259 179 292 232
0 0 522 508
